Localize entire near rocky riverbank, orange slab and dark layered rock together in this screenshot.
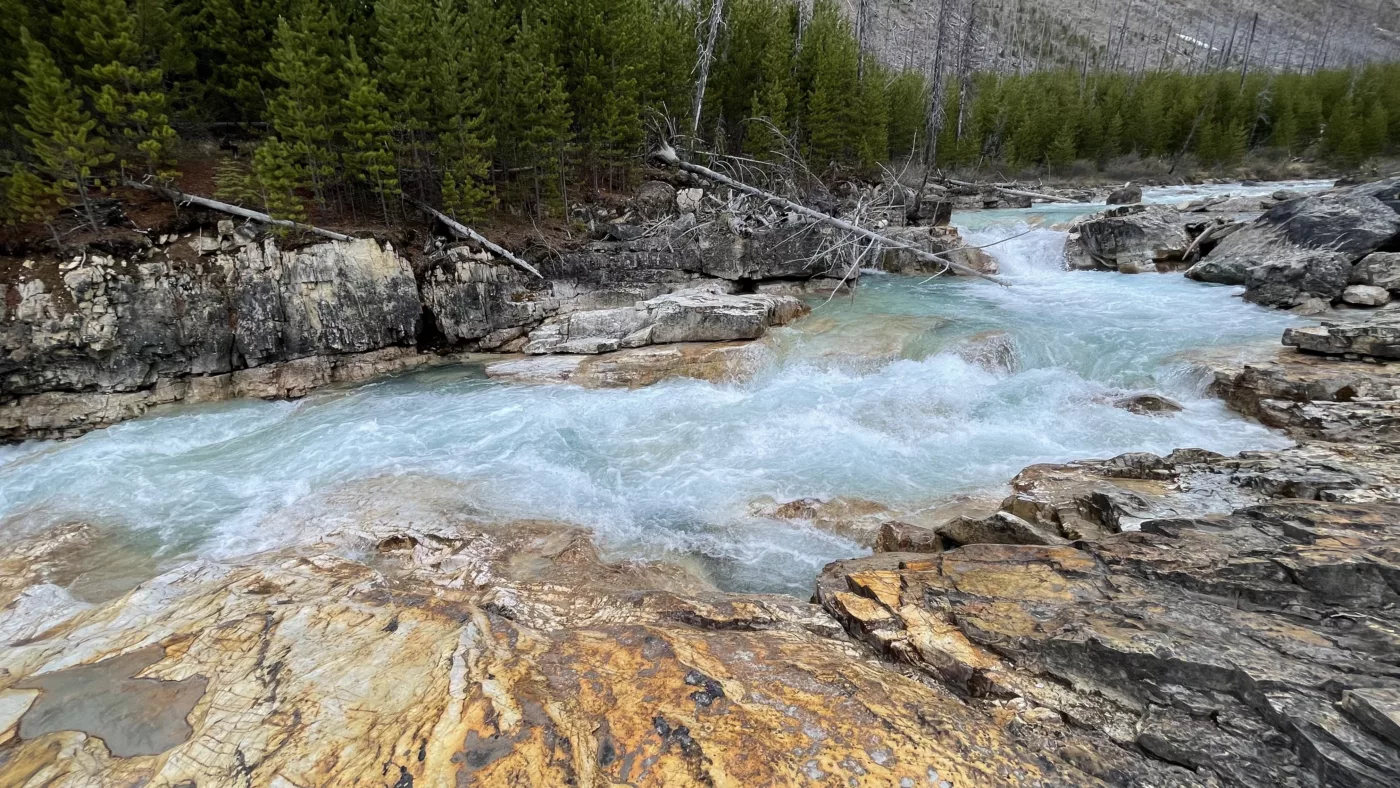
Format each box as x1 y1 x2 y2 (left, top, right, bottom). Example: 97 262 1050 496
0 292 1400 788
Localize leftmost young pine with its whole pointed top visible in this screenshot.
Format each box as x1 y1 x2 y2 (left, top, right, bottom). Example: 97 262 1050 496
20 28 112 230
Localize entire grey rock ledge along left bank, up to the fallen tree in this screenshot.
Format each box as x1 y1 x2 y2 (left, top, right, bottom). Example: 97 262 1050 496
0 215 844 441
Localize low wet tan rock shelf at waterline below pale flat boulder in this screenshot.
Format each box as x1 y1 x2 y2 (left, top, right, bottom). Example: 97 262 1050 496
486 342 764 389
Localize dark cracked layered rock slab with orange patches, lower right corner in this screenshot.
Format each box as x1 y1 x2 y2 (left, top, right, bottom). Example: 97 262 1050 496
818 502 1400 788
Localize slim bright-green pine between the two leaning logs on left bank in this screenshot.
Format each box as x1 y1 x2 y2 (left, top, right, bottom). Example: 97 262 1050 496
340 38 399 224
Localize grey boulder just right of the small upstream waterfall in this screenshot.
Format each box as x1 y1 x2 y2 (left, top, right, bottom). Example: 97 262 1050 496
1065 204 1191 273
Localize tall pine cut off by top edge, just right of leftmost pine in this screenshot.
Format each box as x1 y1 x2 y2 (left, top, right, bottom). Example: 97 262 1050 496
62 0 175 175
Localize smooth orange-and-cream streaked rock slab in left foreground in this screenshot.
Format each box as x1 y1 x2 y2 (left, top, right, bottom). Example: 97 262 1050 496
0 484 1191 788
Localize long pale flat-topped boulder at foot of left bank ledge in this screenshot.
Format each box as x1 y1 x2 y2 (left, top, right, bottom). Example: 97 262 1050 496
525 291 809 354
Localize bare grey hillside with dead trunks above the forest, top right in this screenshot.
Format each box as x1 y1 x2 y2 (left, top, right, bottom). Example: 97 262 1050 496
839 0 1400 71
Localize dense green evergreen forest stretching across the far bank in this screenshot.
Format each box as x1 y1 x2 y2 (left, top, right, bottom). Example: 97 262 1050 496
0 0 1400 225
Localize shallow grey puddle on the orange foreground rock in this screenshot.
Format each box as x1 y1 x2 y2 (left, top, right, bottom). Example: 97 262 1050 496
15 645 207 757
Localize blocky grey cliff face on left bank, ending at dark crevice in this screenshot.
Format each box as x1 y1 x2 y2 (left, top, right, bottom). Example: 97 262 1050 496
0 235 423 439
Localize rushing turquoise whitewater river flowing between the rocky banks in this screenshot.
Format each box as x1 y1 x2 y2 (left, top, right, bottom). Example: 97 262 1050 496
0 181 1321 595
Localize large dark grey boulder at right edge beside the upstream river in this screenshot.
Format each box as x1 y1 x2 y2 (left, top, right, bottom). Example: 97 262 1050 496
1186 178 1400 308
